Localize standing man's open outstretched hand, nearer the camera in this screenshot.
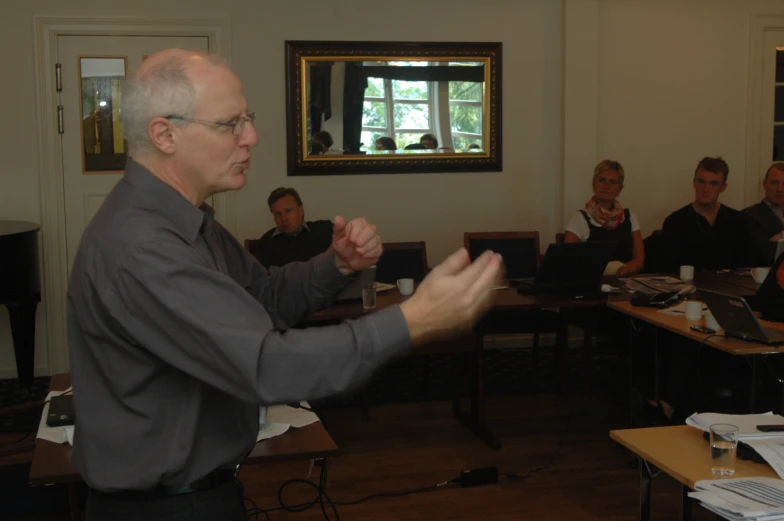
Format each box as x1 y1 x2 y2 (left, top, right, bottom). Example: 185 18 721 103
400 248 504 345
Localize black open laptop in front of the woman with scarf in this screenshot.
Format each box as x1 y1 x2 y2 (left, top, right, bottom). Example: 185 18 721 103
520 241 616 298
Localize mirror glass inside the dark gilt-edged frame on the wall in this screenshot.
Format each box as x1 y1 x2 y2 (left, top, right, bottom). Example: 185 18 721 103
303 58 488 159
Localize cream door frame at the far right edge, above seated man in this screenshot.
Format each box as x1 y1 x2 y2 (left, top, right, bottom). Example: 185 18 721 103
744 12 784 206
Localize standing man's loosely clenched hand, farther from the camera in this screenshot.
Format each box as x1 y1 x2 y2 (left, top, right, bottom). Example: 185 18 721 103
332 216 383 275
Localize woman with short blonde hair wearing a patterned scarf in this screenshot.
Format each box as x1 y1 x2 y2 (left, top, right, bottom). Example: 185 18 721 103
564 159 645 275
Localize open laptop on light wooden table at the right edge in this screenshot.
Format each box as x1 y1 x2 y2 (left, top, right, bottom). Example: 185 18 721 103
699 289 784 346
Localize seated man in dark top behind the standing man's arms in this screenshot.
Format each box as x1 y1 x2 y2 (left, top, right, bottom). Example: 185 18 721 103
251 187 332 268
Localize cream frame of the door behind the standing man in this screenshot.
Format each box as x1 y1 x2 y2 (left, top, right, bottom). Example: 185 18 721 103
33 16 236 374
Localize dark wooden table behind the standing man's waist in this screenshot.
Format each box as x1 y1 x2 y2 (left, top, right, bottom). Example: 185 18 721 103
29 374 338 519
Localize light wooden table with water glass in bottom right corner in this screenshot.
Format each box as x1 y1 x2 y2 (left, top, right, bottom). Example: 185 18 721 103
610 425 778 521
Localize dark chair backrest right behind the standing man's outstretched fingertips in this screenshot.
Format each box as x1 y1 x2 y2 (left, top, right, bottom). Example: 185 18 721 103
463 232 542 279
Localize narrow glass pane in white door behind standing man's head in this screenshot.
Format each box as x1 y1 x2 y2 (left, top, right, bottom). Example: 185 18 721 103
79 57 126 174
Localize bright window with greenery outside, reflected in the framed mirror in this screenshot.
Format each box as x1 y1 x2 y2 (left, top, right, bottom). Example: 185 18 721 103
362 62 484 152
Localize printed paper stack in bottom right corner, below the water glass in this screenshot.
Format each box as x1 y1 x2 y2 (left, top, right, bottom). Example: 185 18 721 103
689 478 784 521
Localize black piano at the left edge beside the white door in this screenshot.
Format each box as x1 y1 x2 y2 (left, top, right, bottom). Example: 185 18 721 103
0 221 41 385
